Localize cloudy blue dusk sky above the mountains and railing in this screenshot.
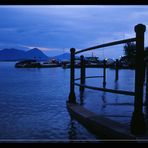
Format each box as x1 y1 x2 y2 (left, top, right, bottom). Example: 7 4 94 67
0 5 148 59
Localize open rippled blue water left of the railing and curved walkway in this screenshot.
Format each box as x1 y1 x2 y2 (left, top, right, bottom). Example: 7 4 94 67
0 62 96 141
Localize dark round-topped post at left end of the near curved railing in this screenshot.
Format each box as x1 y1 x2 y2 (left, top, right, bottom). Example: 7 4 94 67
68 48 76 103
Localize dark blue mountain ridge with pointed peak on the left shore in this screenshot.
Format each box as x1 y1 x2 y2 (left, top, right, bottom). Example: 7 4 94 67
0 48 48 61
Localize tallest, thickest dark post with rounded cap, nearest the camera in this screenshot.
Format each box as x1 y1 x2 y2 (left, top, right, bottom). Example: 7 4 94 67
131 24 146 134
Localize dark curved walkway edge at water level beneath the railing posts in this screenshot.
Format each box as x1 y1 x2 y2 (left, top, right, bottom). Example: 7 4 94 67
67 103 136 140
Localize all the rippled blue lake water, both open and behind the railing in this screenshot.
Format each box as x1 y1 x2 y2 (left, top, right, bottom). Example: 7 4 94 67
0 62 148 141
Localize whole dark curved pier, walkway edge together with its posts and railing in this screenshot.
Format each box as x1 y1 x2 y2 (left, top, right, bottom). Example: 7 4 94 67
67 24 148 141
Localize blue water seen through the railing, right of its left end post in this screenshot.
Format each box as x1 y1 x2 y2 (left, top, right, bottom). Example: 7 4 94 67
77 69 148 126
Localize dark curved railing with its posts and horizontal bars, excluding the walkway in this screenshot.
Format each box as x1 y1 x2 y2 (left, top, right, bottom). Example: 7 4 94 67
69 24 146 134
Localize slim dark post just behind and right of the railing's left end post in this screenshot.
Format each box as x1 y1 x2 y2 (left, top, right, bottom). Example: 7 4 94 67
80 55 85 92
